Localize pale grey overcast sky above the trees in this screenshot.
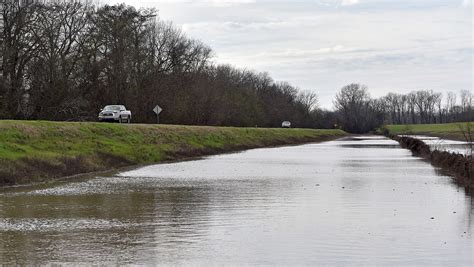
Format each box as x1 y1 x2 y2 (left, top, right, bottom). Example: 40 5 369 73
102 0 473 108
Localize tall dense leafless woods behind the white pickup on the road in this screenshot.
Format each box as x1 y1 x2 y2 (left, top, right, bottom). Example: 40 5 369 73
0 0 317 127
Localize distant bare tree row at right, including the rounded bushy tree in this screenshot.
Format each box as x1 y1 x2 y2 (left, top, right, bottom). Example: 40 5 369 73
332 84 474 133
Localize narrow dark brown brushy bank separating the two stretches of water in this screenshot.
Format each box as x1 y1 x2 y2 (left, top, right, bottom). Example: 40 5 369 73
389 135 474 189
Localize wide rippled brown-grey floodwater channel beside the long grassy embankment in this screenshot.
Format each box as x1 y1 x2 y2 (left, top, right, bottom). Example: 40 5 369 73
0 137 474 266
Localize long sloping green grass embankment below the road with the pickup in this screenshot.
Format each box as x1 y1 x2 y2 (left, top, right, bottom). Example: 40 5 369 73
0 121 346 185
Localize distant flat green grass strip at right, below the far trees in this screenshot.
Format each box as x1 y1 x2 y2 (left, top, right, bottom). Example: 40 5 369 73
385 122 468 141
